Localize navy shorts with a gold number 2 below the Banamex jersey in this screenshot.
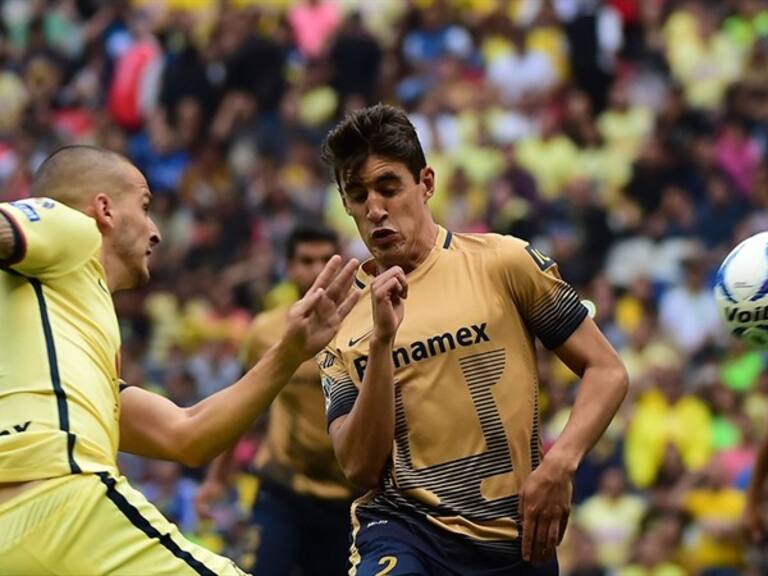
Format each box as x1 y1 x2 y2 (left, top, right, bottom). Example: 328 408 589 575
351 511 559 576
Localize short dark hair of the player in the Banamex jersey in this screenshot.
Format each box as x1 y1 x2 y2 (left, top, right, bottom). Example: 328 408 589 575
320 104 427 191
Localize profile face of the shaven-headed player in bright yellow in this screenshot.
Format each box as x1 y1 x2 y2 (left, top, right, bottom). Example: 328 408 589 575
112 166 160 288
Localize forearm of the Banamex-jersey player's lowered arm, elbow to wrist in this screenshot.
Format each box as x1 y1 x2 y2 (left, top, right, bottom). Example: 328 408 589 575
545 358 629 473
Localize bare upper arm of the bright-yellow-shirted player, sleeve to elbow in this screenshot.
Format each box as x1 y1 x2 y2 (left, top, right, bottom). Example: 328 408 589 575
120 386 194 460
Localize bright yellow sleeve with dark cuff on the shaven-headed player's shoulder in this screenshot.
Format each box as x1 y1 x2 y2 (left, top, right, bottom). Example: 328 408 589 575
0 198 101 279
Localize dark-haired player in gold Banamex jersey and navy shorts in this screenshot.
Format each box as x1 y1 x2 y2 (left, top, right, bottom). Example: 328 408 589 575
317 105 627 576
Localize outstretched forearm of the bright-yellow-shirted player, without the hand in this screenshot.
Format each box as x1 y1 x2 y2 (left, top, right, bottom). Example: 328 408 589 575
184 343 305 463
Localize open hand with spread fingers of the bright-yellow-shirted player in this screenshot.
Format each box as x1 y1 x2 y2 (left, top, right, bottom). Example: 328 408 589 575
283 255 360 360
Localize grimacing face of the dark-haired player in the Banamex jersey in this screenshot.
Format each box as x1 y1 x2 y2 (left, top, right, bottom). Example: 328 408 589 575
342 156 434 268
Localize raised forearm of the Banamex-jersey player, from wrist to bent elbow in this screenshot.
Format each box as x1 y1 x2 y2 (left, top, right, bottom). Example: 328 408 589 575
334 341 395 488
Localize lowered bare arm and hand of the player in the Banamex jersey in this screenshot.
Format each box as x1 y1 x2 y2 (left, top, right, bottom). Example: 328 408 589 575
520 318 629 562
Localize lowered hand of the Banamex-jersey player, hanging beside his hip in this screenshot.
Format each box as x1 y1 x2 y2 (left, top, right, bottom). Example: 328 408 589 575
519 458 573 564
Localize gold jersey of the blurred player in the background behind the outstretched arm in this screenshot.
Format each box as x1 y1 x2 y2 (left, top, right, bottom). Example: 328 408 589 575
245 306 353 499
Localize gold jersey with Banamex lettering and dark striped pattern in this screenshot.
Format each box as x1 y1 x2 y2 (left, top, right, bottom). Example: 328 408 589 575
317 228 587 562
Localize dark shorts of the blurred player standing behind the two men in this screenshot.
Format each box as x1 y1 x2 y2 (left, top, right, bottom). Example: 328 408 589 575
243 482 351 576
